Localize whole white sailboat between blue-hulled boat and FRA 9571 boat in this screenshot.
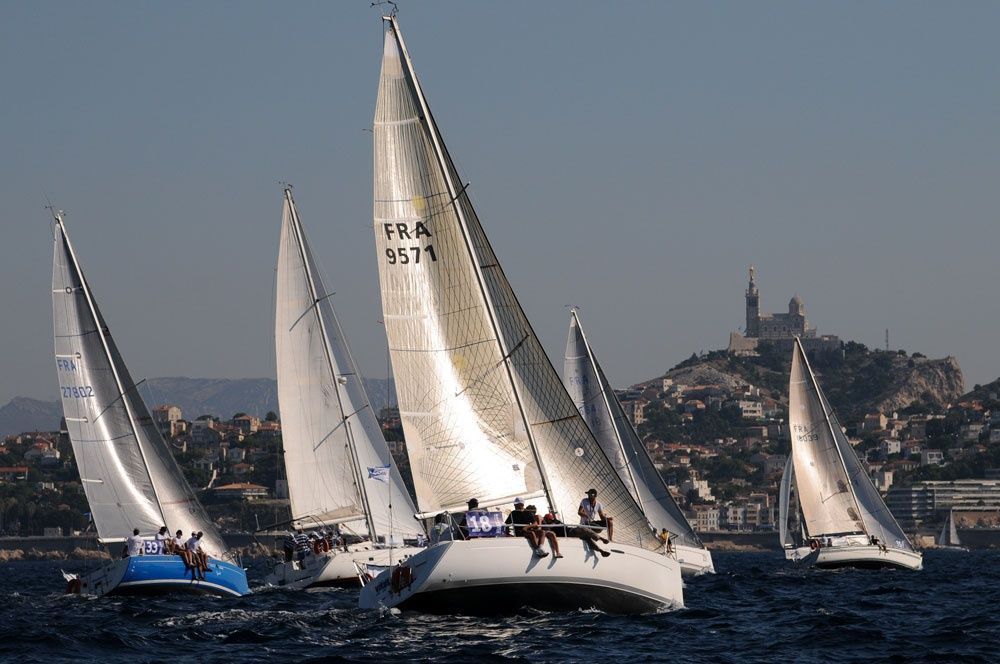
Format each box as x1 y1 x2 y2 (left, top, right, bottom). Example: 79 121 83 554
265 186 424 588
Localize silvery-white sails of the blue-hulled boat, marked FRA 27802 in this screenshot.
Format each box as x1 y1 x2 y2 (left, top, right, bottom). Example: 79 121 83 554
52 212 226 557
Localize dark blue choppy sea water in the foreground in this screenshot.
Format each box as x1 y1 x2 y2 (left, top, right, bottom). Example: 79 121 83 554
0 551 1000 664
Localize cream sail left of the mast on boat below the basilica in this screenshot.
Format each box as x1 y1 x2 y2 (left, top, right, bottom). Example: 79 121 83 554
788 340 865 537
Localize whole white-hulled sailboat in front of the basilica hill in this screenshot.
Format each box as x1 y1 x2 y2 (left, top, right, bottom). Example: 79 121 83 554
781 338 923 570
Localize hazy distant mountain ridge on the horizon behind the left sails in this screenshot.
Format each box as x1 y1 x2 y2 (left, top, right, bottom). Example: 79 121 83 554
0 378 396 435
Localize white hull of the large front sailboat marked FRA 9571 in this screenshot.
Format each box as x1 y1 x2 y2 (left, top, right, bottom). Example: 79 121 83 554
359 537 684 614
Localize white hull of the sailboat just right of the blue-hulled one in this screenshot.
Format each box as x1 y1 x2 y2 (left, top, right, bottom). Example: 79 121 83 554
264 542 423 590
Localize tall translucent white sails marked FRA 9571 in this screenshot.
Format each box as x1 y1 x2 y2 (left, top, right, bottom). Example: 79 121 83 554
374 17 659 549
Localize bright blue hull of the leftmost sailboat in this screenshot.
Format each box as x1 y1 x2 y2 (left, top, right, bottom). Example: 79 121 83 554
69 555 250 597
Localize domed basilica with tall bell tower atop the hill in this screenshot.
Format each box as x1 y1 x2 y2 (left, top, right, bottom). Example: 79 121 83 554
728 265 840 355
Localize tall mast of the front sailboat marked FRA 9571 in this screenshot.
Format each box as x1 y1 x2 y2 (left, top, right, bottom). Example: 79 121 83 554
382 15 558 512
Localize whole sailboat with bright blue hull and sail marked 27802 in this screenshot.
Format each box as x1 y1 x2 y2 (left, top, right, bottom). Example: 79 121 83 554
52 210 250 596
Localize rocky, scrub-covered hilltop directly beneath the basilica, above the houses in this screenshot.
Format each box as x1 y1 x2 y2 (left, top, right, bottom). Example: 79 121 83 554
636 341 965 419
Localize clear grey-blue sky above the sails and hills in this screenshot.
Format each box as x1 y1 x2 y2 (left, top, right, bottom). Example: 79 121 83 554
0 0 1000 403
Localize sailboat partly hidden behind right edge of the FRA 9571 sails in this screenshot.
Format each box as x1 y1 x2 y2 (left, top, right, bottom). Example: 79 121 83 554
563 309 715 576
